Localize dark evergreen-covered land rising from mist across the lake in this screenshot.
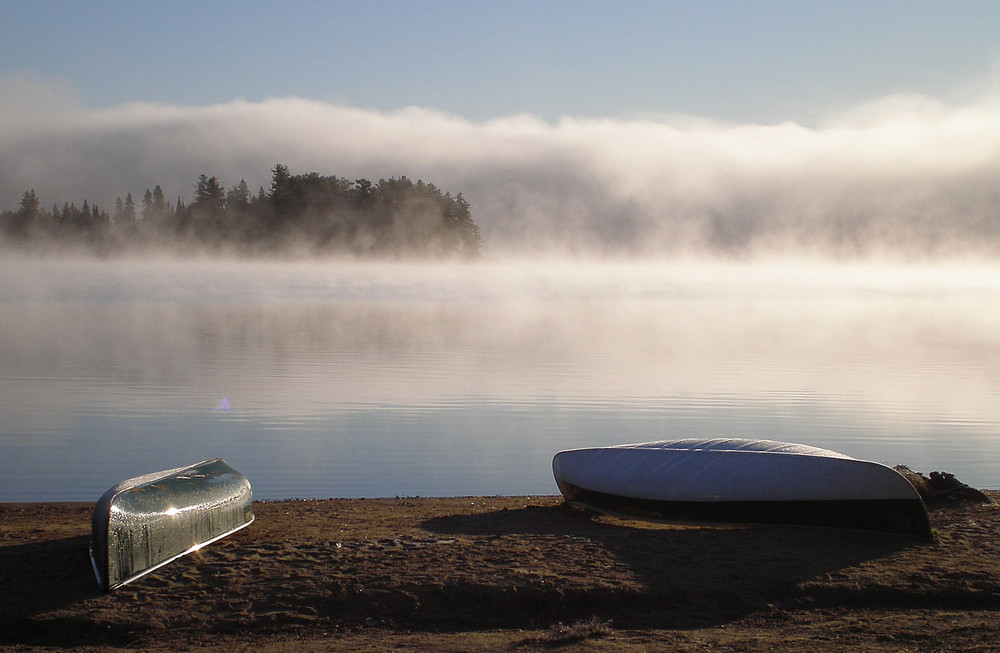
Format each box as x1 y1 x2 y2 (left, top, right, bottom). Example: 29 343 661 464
0 164 482 257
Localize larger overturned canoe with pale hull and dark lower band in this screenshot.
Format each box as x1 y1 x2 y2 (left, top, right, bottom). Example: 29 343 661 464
552 439 931 538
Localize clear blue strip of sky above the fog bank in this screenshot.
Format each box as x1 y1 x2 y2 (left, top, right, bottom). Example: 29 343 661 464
0 0 1000 123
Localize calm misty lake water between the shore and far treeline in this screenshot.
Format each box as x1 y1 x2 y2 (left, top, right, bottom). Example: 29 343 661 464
0 259 1000 501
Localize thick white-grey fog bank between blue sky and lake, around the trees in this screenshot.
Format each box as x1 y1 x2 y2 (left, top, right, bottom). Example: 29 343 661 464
0 77 1000 256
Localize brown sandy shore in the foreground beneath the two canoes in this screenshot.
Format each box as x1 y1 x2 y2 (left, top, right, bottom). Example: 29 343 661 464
0 493 1000 653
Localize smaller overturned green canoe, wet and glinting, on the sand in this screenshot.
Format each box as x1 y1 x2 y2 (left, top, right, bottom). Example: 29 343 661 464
90 458 254 591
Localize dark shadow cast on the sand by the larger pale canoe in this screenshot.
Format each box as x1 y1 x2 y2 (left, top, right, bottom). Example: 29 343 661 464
423 506 925 628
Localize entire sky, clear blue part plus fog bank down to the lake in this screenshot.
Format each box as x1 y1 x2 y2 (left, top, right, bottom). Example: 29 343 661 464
0 0 1000 258
